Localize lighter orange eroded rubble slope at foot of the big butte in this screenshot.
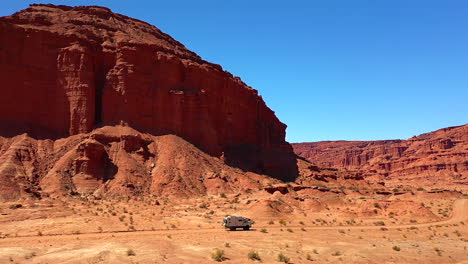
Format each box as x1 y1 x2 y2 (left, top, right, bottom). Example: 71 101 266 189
0 126 277 201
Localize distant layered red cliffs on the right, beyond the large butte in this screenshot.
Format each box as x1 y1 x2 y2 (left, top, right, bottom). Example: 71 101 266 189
293 125 468 187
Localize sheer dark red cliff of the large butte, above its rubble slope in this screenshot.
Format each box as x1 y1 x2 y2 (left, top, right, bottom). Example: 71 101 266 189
0 5 297 180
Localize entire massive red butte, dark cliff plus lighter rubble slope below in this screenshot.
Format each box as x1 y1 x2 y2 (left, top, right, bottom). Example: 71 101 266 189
0 4 298 199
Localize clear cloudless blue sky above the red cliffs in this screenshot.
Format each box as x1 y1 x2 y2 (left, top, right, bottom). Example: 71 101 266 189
0 0 468 142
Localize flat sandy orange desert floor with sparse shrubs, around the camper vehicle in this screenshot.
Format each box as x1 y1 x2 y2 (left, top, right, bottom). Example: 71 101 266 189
0 190 468 264
